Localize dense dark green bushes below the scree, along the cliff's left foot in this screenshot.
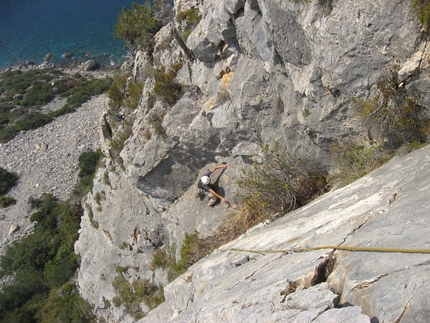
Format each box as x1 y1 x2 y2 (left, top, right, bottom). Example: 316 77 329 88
0 152 100 323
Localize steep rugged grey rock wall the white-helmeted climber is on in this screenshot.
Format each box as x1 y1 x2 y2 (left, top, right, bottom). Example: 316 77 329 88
76 0 429 322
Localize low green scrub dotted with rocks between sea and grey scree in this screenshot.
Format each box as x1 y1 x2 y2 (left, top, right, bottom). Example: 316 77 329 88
0 69 111 143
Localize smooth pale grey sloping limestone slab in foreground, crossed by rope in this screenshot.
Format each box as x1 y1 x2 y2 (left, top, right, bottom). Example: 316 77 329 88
138 146 430 323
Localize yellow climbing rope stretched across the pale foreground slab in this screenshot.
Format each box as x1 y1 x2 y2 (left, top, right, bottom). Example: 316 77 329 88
220 246 430 254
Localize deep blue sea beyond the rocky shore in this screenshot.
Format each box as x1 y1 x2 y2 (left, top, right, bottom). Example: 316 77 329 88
0 0 145 69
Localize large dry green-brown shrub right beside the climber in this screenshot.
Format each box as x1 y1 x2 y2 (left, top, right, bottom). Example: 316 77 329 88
238 142 326 227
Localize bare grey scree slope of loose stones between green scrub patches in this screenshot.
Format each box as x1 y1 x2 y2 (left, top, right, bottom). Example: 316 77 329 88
0 95 108 254
